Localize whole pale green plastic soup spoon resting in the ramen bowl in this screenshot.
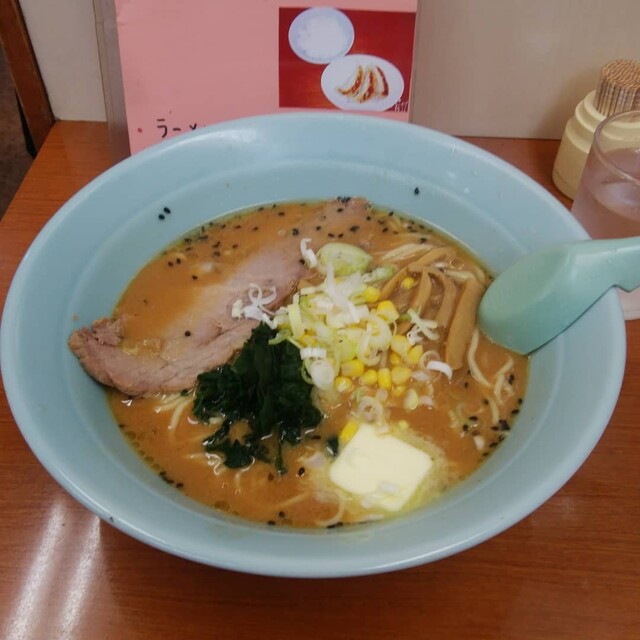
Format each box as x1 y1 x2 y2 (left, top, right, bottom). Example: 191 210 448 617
478 237 640 353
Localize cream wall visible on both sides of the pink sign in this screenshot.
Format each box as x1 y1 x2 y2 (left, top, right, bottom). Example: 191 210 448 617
21 0 640 138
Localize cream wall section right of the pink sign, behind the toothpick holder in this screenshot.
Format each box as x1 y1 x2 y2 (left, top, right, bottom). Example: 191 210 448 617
413 0 640 138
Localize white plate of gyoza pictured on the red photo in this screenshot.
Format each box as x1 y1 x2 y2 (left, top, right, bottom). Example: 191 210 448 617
320 54 404 111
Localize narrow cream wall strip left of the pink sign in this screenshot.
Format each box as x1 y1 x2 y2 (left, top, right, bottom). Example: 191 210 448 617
20 0 105 120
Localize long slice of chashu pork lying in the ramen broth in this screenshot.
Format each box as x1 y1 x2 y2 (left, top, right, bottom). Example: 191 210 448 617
69 198 368 396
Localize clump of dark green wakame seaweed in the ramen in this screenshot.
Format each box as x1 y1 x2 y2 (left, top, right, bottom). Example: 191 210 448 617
193 323 322 473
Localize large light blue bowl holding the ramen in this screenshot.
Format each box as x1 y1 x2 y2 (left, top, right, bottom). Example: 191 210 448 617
0 114 625 577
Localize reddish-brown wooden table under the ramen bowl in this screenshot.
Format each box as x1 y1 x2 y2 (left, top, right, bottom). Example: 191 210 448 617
0 122 640 640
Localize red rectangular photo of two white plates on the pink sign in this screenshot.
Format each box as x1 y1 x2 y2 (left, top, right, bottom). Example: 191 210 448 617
279 7 416 112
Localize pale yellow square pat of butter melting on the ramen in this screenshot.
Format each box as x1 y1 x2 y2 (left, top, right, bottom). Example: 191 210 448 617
329 424 433 511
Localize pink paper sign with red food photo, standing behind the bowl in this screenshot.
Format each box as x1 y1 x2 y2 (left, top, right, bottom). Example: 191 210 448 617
115 0 417 153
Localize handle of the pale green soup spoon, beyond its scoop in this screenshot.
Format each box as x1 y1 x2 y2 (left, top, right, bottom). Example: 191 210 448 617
578 236 640 291
